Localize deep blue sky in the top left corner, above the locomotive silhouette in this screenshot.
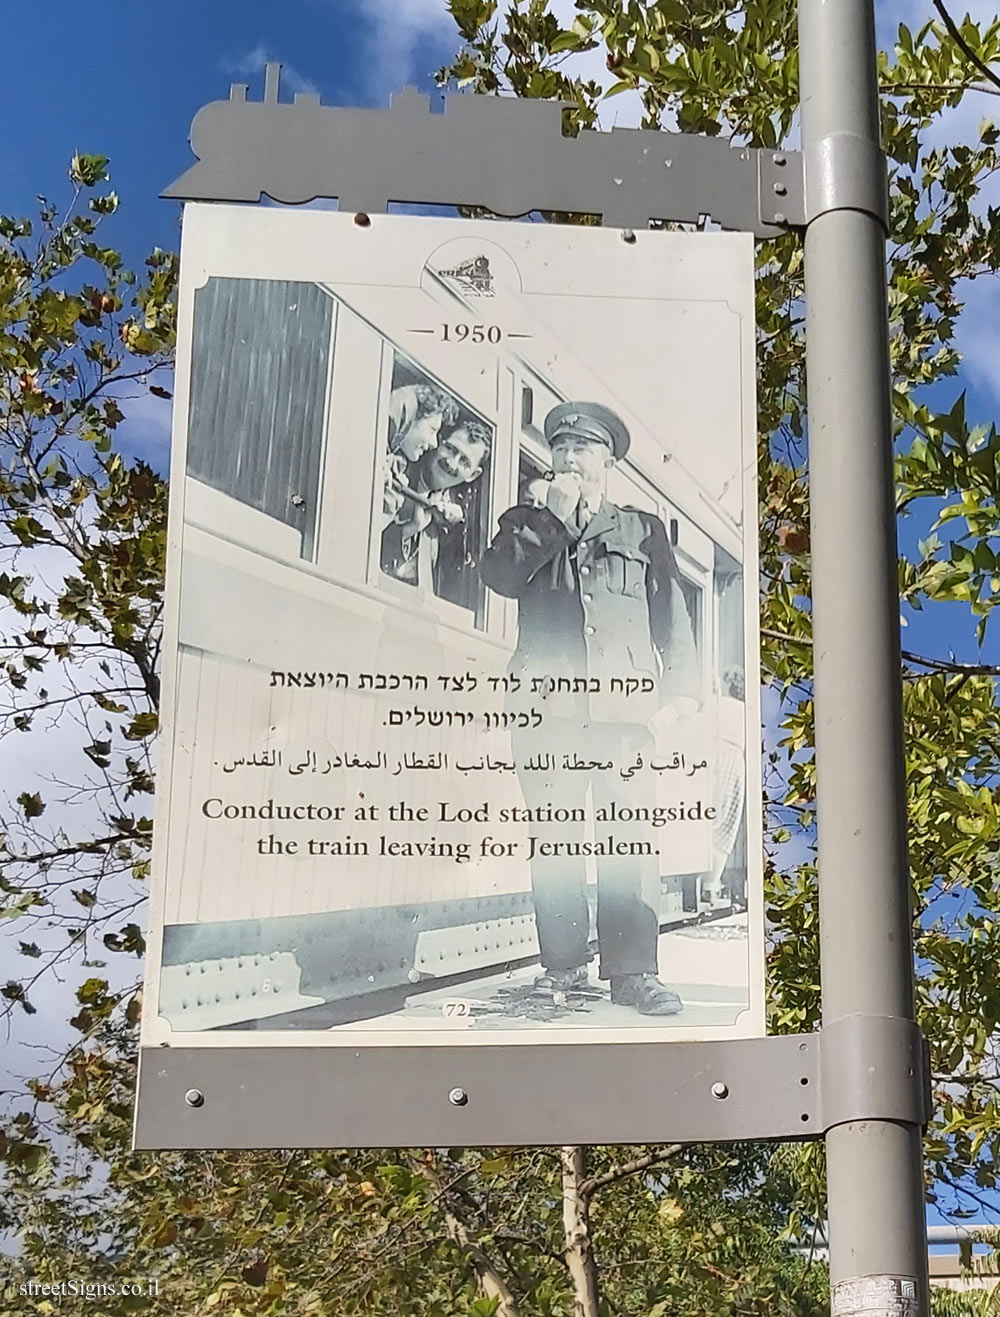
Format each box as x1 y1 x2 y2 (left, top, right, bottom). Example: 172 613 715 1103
0 0 457 272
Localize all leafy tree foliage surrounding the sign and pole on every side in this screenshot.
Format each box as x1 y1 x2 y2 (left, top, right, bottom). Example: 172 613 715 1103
0 0 1000 1317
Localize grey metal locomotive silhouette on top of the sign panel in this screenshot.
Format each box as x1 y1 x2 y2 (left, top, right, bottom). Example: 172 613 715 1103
163 65 806 238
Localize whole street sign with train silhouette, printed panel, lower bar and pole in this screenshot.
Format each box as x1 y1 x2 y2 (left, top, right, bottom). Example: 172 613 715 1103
134 15 930 1314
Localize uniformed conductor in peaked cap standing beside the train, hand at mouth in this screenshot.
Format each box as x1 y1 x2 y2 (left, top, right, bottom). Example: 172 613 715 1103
481 402 700 1015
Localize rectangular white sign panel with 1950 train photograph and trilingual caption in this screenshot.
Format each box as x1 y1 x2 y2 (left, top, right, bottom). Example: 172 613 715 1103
140 205 763 1146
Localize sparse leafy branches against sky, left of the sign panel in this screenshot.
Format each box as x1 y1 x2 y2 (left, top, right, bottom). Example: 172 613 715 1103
0 155 177 1033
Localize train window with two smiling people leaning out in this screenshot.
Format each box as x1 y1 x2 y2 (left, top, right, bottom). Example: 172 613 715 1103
379 352 495 628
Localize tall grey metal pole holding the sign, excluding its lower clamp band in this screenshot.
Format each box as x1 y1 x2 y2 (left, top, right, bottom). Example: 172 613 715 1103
798 0 929 1317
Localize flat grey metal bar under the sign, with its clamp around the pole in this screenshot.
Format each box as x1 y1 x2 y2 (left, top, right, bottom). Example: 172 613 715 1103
134 1017 929 1148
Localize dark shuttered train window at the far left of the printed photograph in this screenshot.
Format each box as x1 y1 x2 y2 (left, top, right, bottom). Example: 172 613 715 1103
187 278 333 558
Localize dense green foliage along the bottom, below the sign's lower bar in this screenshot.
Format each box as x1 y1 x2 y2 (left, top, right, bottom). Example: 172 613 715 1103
0 1023 826 1317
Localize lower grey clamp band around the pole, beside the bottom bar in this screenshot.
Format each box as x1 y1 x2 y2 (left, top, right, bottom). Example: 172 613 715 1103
819 1015 930 1130
